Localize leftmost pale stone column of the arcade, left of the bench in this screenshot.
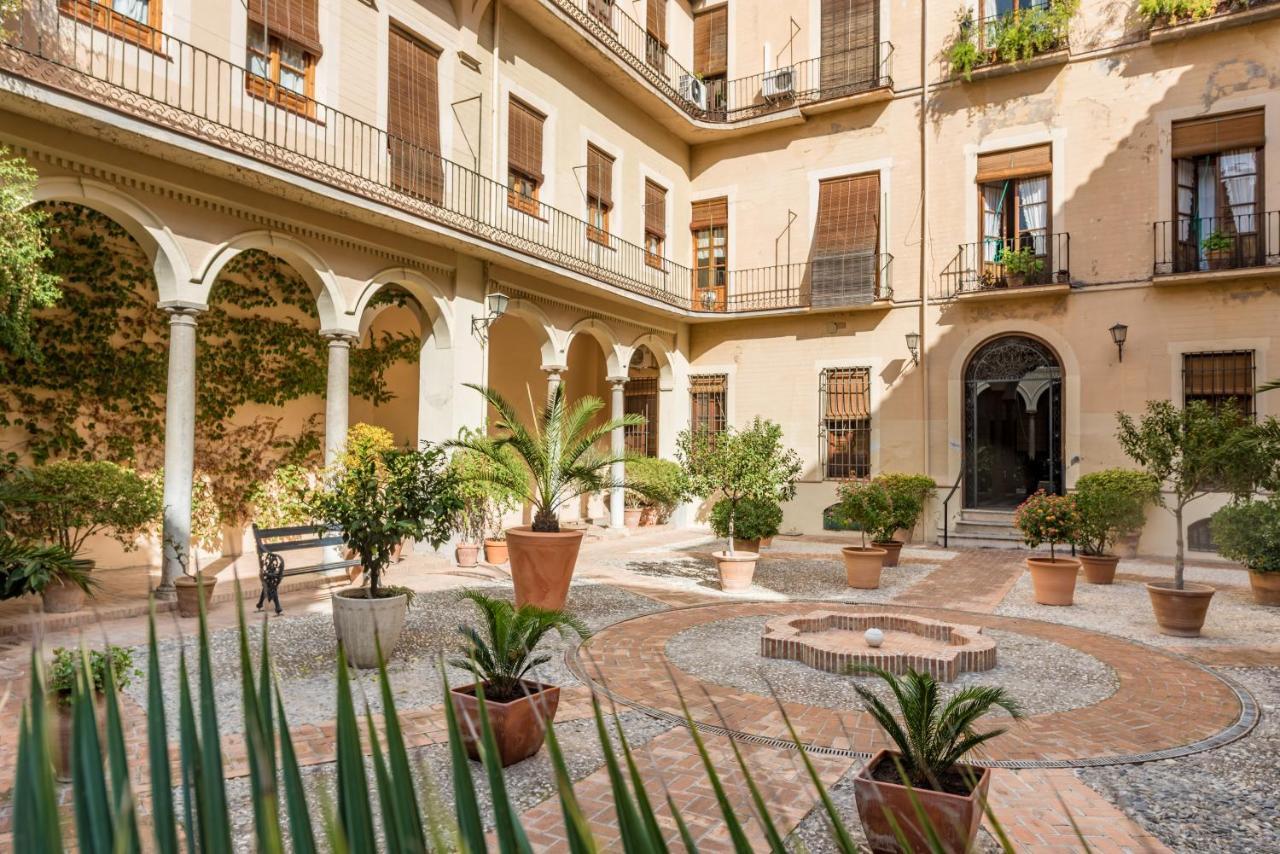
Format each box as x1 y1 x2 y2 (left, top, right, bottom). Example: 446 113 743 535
155 305 202 599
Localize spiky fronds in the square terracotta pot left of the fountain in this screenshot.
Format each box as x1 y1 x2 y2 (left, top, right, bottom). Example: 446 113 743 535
449 590 591 703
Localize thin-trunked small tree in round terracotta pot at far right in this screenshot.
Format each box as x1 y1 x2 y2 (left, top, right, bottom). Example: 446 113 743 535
1116 401 1271 638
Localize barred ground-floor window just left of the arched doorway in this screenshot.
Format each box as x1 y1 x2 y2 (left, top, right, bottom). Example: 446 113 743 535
818 367 872 480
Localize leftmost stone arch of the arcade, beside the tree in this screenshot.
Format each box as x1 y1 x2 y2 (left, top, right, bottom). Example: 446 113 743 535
33 178 192 307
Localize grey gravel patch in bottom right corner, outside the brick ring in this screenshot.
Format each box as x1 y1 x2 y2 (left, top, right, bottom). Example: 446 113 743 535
1076 667 1280 854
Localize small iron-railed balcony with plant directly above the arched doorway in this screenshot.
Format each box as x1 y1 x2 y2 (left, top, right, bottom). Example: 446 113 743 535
941 232 1071 300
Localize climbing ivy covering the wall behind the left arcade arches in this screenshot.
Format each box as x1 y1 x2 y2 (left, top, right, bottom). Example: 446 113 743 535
0 204 419 524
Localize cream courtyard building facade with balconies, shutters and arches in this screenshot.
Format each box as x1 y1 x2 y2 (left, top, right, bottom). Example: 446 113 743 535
0 0 1280 583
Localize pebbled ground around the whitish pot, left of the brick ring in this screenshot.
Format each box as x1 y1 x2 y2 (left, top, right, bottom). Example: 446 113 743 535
128 584 662 735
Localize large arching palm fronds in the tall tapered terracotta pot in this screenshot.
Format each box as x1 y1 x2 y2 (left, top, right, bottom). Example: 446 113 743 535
447 383 646 534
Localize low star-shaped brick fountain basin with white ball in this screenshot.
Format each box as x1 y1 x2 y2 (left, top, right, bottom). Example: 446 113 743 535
760 611 996 682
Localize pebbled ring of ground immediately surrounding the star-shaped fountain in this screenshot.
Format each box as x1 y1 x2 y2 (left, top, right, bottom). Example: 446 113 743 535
667 617 1117 714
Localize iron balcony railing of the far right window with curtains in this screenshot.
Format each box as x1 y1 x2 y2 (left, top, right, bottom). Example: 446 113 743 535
1155 210 1280 275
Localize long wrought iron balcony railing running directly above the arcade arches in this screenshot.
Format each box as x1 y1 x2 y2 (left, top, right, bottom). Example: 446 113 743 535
0 0 887 317
